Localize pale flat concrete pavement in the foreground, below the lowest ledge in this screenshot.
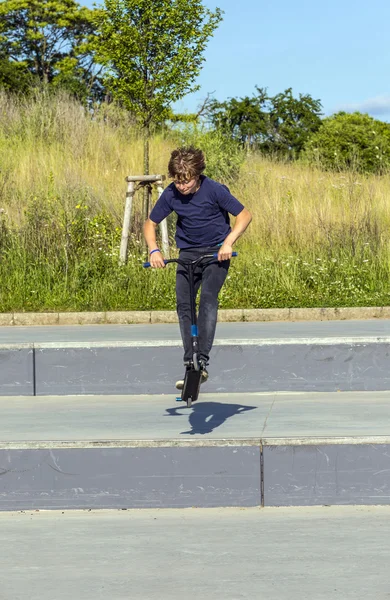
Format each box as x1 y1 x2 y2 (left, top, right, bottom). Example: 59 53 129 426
0 507 390 600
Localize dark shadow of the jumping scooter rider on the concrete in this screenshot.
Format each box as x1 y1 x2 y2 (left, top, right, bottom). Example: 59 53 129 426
167 401 257 435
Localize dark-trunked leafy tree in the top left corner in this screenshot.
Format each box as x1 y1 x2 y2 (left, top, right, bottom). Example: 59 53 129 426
0 0 99 101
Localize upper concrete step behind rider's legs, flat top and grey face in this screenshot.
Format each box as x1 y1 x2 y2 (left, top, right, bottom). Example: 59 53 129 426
0 320 390 396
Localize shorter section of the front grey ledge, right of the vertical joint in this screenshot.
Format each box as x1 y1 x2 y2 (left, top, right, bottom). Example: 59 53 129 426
263 440 390 506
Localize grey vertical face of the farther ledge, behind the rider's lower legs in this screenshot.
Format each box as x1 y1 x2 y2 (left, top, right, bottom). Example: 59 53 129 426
0 337 390 396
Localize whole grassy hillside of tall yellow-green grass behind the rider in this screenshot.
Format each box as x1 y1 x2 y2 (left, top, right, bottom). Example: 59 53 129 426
0 95 390 312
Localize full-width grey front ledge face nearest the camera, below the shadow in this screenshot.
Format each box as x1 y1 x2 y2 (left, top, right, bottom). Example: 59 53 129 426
0 438 390 511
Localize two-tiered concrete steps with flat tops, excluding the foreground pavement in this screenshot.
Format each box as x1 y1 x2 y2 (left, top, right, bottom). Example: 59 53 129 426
0 320 390 510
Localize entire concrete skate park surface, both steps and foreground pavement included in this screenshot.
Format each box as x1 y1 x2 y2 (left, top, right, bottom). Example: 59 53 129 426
0 319 390 600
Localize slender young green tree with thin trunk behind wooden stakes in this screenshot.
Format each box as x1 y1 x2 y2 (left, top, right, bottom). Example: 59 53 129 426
94 0 222 216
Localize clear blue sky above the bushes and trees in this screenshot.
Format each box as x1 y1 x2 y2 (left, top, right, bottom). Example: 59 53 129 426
84 0 390 121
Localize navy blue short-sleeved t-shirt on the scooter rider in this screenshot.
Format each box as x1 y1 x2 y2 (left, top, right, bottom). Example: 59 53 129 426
150 175 244 248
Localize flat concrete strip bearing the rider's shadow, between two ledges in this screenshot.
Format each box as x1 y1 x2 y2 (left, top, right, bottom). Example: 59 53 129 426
0 392 390 442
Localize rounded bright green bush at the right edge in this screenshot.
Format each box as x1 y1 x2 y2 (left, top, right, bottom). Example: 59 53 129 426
303 112 390 174
